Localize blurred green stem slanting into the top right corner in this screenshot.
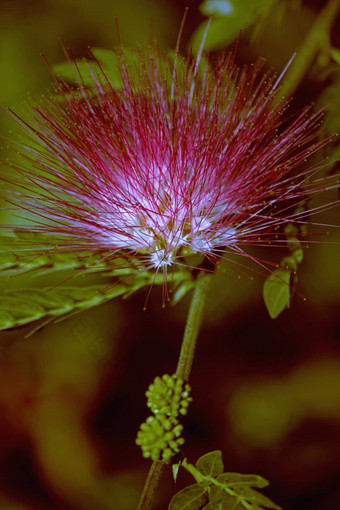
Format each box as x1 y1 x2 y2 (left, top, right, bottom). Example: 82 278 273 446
280 0 340 97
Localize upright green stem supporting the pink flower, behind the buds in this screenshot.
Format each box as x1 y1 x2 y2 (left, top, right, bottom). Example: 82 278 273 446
137 272 209 510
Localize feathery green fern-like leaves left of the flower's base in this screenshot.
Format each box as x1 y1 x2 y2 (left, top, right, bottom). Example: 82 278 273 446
0 230 193 330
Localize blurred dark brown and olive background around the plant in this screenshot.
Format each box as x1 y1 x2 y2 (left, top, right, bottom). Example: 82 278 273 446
0 0 340 510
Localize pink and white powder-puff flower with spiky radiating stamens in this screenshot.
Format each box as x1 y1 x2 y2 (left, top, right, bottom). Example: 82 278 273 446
1 48 338 278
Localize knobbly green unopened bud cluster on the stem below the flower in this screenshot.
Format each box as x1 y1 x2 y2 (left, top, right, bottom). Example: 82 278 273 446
136 374 192 463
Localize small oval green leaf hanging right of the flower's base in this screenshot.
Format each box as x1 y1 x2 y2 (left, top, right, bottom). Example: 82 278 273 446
263 269 291 319
